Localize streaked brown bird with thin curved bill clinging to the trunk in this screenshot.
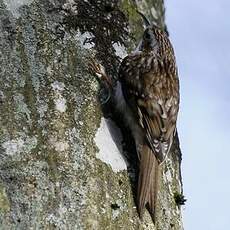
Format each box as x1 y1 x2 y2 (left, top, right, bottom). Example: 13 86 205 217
89 11 180 222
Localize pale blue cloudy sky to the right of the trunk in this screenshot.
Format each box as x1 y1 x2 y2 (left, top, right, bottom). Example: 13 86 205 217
165 0 230 230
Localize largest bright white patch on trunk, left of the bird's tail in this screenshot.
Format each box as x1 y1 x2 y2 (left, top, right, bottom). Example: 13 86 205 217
94 118 127 172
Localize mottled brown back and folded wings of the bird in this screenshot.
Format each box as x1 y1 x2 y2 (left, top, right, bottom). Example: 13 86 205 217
119 52 179 163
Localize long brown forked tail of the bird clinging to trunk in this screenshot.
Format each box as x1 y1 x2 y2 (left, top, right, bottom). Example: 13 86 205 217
137 145 159 222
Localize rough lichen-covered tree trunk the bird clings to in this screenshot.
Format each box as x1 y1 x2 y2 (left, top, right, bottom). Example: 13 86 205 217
0 0 183 230
